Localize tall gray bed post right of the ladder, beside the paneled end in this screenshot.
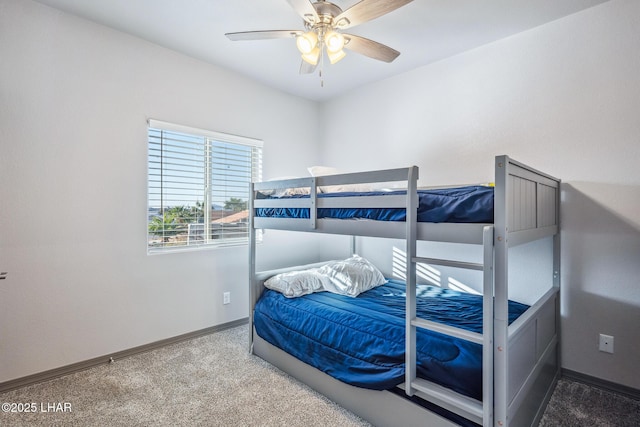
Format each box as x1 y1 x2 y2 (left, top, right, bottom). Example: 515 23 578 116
493 156 510 427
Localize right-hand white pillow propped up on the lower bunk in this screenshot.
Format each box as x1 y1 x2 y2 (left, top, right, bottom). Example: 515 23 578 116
318 255 386 297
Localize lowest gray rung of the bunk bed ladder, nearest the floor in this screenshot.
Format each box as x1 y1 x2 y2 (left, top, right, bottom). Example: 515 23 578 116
411 378 484 425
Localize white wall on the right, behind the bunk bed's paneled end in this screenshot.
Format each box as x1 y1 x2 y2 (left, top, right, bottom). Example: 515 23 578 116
322 0 640 388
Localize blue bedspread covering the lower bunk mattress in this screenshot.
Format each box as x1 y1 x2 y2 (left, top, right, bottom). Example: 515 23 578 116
254 280 528 400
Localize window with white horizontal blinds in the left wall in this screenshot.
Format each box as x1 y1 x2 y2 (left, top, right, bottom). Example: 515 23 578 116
147 120 262 253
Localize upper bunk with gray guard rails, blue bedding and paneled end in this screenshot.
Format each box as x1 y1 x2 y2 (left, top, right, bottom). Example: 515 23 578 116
250 156 560 246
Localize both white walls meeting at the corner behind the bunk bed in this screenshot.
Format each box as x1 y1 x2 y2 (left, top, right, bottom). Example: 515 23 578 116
0 0 640 388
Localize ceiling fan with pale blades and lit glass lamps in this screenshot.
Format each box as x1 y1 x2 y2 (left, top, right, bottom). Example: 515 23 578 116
225 0 413 74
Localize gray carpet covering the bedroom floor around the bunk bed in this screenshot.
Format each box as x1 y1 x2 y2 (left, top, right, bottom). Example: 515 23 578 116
0 326 640 427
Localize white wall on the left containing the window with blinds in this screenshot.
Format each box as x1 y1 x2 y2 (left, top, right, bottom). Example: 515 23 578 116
0 0 319 382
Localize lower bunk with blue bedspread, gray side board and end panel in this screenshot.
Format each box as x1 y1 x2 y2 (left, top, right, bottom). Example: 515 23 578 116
252 262 559 426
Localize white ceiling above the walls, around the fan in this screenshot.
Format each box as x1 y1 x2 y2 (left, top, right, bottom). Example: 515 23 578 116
32 0 608 101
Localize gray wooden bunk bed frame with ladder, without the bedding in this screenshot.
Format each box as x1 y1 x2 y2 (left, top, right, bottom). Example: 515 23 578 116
249 155 560 427
